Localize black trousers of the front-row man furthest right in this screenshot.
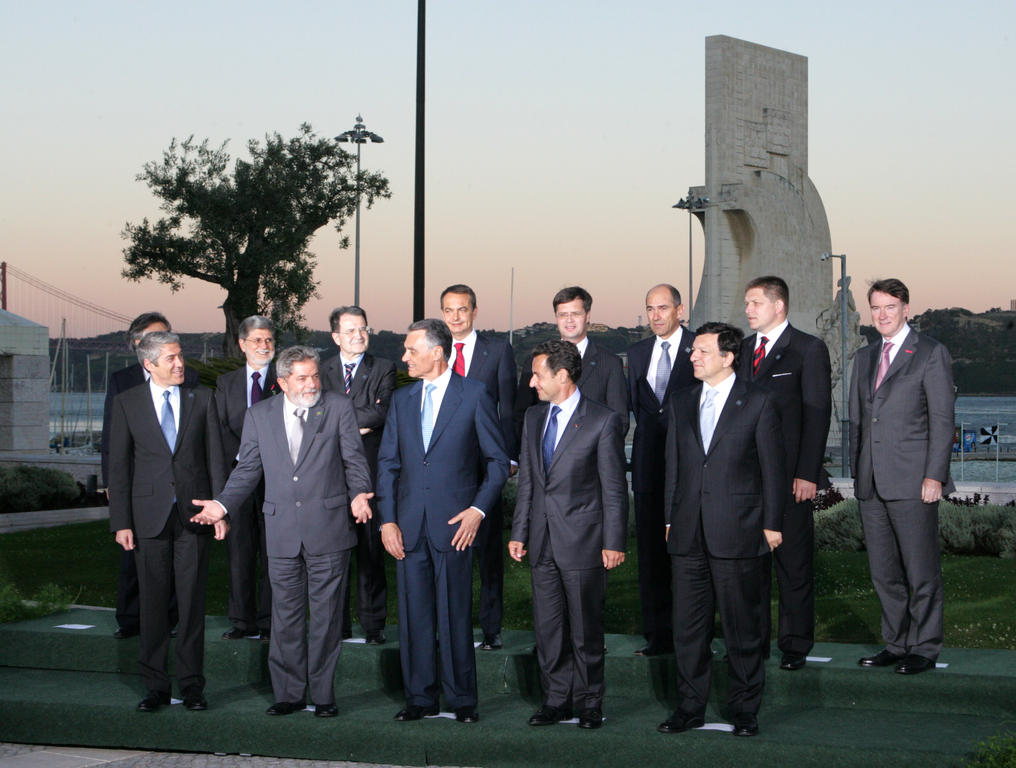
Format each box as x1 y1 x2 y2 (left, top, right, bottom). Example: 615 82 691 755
672 552 765 715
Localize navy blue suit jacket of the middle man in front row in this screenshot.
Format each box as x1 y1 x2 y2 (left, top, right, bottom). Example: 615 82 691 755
377 373 508 552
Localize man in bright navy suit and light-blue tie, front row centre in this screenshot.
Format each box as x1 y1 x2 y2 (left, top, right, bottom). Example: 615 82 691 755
377 319 508 722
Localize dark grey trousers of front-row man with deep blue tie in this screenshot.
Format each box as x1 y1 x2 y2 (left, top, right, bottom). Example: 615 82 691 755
530 538 607 710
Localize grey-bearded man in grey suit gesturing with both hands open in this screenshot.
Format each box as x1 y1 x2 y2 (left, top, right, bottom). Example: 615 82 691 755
193 346 372 717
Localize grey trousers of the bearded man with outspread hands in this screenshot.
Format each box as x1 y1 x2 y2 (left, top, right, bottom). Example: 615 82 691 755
268 548 350 706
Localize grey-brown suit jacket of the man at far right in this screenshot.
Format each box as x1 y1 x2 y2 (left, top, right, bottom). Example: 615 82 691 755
849 329 956 501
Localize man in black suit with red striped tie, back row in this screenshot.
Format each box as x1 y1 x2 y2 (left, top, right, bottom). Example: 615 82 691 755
738 275 832 671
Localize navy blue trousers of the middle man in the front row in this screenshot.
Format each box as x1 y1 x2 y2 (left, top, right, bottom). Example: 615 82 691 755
396 524 477 709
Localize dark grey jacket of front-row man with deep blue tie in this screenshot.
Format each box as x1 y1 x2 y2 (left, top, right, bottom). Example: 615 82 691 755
511 397 628 570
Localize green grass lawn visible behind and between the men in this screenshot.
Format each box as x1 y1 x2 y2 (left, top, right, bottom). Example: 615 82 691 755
0 521 1016 650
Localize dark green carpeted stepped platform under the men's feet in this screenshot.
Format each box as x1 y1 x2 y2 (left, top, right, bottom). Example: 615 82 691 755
0 610 1016 768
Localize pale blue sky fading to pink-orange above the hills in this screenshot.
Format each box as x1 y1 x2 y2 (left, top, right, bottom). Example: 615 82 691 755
0 0 1016 331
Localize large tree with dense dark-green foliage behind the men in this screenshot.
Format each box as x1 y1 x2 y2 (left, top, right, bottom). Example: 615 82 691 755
122 123 391 355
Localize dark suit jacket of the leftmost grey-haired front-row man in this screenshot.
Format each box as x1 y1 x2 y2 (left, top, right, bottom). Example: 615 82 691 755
109 386 225 538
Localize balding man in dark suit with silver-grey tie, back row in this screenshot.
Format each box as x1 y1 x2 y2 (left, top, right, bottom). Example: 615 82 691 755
628 284 695 656
